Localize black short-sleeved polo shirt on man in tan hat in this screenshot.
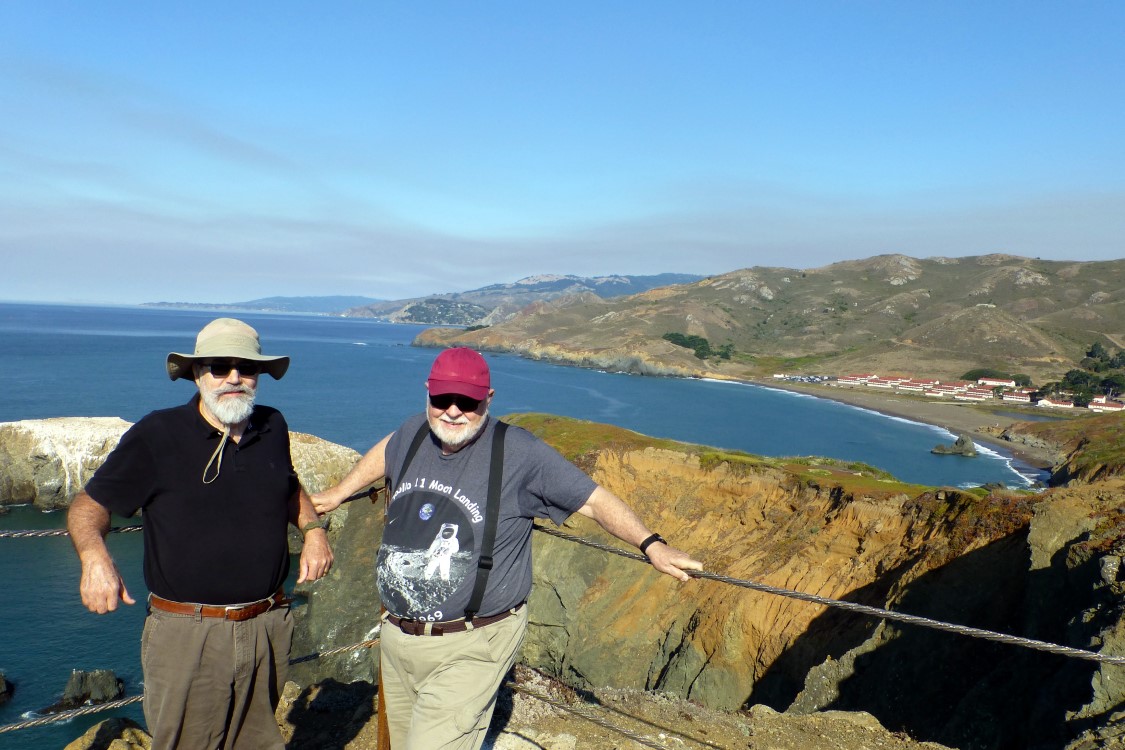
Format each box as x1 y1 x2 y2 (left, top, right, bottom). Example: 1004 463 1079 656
86 394 299 605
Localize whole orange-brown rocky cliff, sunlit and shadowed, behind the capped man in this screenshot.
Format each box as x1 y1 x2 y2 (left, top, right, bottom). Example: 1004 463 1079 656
309 416 1125 749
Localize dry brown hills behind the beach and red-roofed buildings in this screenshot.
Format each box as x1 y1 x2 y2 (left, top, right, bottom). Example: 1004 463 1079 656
411 255 1125 382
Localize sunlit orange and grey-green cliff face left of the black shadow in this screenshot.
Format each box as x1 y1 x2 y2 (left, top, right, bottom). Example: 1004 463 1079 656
524 449 933 710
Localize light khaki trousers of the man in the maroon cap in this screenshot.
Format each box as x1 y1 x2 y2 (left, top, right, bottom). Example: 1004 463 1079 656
379 605 528 750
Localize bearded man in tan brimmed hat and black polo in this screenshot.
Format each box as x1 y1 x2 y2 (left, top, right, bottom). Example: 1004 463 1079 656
68 318 332 750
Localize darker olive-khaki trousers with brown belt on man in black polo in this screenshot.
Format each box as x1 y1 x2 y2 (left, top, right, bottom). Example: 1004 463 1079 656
141 607 293 750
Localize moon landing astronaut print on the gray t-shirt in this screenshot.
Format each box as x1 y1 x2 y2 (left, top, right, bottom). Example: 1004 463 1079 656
377 490 480 621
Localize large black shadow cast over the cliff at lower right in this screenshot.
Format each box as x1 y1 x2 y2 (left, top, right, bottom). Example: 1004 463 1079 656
752 533 1113 750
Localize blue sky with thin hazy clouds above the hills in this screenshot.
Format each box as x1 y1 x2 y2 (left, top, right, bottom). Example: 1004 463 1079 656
0 0 1125 304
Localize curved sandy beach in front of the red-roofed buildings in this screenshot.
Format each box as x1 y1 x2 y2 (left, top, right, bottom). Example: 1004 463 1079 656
752 379 1053 469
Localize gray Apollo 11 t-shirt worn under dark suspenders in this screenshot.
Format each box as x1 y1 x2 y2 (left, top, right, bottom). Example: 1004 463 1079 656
376 415 596 621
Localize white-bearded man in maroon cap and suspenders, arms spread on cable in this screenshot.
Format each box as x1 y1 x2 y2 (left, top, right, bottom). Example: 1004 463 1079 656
313 347 702 750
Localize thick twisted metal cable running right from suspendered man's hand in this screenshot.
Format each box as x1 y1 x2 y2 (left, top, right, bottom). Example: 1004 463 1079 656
533 524 1125 666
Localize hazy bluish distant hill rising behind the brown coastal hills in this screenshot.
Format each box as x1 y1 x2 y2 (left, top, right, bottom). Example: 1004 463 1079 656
345 273 703 326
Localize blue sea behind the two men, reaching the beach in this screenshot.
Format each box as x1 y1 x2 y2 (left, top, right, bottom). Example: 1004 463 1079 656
0 304 1044 750
